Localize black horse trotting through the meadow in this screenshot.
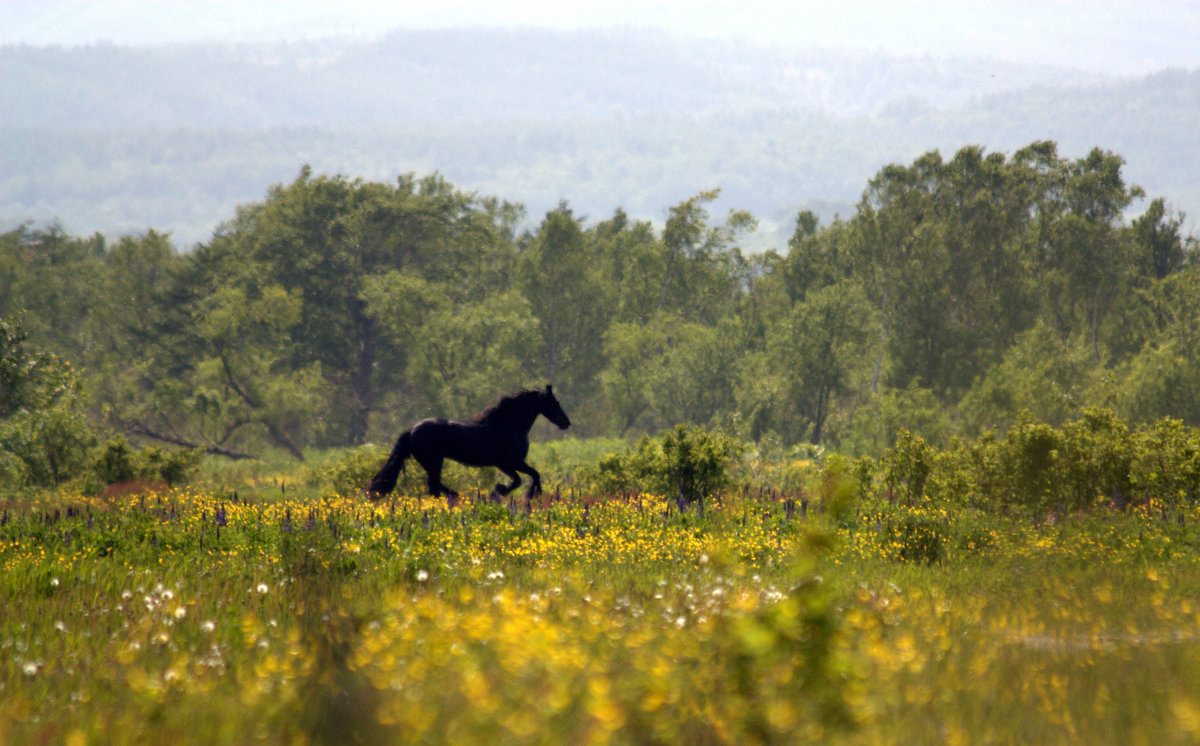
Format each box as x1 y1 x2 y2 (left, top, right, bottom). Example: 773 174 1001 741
367 384 571 500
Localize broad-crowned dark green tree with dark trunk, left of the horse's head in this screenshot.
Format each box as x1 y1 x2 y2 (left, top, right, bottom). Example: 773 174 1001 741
198 168 518 444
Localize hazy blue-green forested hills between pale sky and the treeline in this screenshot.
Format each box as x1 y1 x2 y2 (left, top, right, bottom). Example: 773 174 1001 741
0 30 1200 249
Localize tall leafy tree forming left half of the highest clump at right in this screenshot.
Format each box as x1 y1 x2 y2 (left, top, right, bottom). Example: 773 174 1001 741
841 146 1038 401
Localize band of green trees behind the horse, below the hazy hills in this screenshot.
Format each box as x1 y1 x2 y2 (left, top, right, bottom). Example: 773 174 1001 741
0 142 1200 467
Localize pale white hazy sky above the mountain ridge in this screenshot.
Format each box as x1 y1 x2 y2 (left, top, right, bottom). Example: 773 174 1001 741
7 0 1200 74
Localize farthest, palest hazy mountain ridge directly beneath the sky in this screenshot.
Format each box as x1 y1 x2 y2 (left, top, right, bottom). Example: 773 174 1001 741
0 29 1108 128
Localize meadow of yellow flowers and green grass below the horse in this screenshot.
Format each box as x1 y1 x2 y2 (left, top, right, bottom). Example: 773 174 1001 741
0 477 1200 745
